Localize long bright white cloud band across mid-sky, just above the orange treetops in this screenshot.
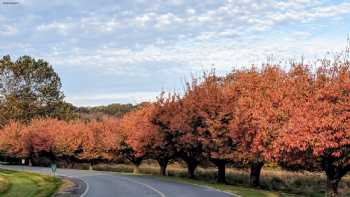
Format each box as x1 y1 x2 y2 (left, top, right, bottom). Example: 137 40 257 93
44 32 344 76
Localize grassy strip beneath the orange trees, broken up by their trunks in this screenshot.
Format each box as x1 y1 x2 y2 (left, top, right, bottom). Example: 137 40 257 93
94 162 334 197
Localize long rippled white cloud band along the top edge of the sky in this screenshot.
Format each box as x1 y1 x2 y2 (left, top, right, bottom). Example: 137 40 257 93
28 0 350 39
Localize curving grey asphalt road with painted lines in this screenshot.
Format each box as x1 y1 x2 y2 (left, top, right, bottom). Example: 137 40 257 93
0 165 233 197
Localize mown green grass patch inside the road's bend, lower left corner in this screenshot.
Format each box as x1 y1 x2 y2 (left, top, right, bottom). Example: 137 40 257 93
0 170 61 197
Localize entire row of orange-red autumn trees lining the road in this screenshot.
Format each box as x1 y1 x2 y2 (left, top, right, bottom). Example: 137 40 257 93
0 58 350 196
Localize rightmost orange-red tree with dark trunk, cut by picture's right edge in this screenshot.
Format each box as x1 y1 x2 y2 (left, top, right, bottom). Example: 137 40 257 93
275 62 350 196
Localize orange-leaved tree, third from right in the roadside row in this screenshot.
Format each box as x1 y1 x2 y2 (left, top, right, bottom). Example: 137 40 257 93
184 72 237 183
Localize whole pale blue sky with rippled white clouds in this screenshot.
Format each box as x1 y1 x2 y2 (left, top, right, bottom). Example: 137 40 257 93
0 0 350 106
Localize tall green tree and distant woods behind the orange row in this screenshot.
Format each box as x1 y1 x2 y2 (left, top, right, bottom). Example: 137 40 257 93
0 55 136 124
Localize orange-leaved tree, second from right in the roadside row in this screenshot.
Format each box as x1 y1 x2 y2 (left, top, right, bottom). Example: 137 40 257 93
227 66 287 186
